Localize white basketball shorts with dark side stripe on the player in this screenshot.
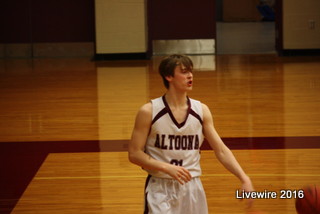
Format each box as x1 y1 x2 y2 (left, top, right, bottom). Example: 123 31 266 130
144 176 208 214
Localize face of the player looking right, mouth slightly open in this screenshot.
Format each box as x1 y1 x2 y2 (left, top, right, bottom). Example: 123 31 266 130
167 64 193 91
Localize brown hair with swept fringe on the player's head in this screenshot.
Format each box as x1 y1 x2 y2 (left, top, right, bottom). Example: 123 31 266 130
159 54 193 89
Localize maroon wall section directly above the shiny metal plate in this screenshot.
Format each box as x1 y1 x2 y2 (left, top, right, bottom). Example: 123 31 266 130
148 0 216 40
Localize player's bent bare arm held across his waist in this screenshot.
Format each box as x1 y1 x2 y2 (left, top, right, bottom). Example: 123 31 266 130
128 103 191 184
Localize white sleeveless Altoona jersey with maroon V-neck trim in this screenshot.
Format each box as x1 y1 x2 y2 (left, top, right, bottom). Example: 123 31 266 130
145 96 204 178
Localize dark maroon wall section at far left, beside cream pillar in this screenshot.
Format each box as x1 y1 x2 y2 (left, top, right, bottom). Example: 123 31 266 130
0 0 95 43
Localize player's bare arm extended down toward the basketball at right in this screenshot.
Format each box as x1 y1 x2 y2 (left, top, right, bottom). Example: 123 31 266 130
202 104 254 205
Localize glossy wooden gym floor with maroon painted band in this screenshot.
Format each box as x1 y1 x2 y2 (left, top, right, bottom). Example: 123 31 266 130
0 54 320 214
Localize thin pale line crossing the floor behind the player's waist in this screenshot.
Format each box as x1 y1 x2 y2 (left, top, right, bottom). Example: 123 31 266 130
33 173 320 180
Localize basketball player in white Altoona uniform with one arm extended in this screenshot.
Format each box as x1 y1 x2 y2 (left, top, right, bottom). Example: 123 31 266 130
129 55 253 214
